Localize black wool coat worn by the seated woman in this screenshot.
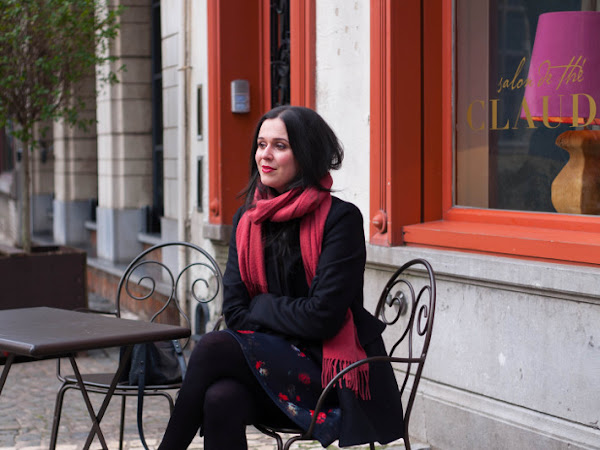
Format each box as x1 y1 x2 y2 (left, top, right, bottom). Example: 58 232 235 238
223 197 404 446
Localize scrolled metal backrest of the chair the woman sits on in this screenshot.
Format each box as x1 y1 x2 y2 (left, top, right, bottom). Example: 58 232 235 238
375 259 436 431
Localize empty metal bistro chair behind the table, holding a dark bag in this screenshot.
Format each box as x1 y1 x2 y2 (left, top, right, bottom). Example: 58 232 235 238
50 242 223 450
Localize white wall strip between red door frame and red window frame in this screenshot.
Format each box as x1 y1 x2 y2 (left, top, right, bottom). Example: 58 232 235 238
316 0 370 237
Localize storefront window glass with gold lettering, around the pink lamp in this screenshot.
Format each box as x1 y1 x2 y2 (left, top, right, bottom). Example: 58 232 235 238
454 0 600 212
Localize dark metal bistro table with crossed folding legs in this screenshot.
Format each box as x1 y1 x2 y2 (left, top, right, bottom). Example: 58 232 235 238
0 307 190 449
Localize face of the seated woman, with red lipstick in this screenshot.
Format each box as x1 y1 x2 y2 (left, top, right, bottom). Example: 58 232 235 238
254 118 300 194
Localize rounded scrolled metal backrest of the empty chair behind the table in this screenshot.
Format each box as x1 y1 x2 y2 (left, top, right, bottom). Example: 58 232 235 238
116 242 223 343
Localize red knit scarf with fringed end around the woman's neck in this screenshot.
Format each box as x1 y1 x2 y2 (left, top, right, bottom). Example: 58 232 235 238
236 174 371 399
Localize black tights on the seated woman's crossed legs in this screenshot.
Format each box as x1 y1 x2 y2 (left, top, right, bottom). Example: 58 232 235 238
159 331 290 450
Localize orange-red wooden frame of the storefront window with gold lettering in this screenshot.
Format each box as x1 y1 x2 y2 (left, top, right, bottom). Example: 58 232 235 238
370 0 600 265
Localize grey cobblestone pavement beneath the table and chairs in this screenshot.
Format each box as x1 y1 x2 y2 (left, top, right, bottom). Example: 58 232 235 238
0 349 410 450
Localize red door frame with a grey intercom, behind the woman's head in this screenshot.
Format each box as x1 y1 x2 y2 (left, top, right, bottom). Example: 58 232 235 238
207 0 315 225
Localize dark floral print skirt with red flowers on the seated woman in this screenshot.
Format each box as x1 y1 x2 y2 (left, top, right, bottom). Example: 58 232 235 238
227 330 341 447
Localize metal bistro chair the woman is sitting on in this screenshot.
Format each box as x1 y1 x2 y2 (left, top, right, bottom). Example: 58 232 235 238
255 259 436 450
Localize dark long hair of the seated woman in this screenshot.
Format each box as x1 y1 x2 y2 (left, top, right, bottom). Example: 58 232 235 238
241 105 344 208
